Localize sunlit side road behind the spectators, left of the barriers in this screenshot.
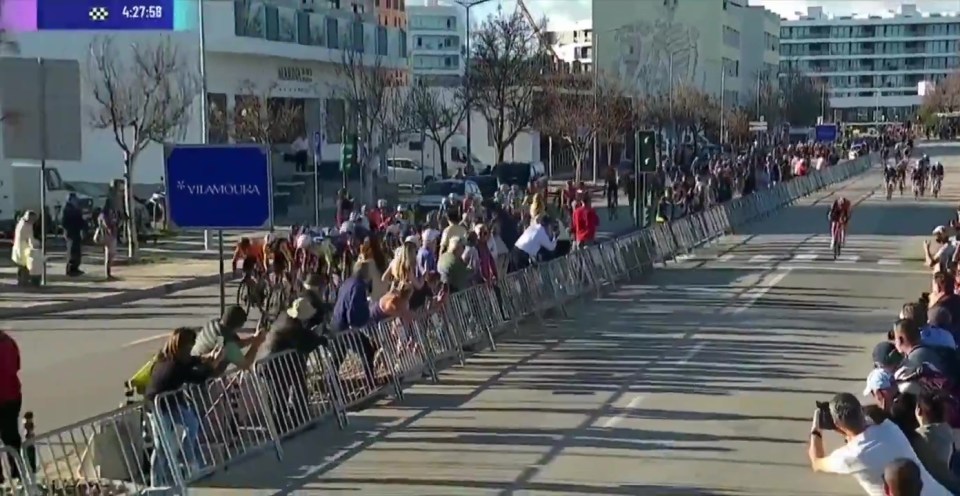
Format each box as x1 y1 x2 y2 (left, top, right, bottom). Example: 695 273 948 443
7 208 629 432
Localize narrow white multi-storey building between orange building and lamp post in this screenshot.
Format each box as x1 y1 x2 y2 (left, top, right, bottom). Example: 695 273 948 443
407 0 467 86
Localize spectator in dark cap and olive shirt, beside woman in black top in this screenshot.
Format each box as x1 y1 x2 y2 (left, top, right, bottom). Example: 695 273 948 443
191 305 267 374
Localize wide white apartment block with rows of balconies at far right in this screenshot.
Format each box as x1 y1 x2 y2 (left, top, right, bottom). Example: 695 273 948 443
780 4 960 123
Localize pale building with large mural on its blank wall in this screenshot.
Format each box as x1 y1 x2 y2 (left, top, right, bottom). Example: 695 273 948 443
591 0 778 105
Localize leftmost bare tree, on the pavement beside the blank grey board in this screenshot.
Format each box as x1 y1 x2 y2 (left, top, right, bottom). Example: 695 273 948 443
86 36 200 260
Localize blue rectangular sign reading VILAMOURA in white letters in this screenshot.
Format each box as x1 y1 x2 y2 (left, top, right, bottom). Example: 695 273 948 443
164 144 273 230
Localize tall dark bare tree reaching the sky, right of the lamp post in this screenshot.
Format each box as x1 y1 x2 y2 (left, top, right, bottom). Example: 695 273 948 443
469 12 551 163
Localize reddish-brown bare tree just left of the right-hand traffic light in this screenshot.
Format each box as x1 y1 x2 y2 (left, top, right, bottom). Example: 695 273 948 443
544 80 627 182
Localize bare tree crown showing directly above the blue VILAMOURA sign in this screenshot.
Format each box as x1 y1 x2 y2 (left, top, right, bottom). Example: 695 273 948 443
210 80 304 146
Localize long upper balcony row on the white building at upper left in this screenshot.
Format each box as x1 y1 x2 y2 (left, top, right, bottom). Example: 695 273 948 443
203 1 407 69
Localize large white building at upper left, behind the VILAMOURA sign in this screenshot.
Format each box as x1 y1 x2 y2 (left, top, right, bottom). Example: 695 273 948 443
0 0 408 184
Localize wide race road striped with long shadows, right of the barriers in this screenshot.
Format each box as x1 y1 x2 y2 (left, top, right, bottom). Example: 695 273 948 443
178 141 960 496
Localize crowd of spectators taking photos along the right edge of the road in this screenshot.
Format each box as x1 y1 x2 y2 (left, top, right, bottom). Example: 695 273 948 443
808 221 960 496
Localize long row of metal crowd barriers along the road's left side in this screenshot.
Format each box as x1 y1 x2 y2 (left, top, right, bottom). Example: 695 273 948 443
0 153 870 496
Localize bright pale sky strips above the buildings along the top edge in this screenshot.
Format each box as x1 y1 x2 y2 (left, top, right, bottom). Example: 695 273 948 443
471 0 960 30
